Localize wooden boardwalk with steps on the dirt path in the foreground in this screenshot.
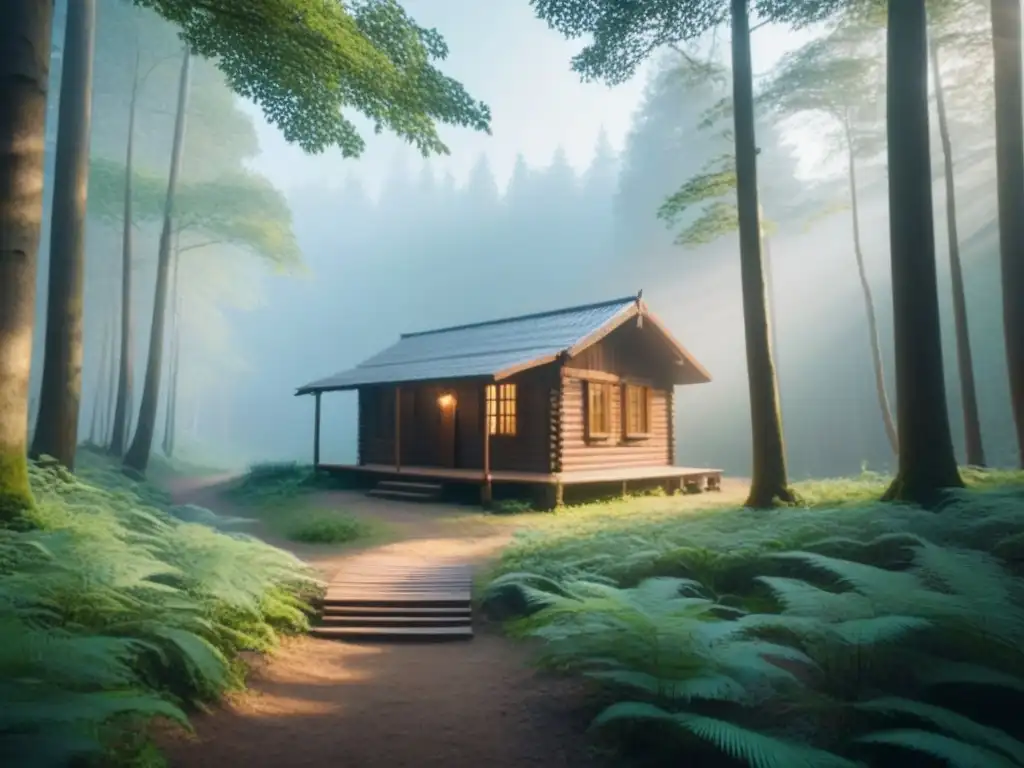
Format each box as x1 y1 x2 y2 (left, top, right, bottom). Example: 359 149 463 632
310 554 473 641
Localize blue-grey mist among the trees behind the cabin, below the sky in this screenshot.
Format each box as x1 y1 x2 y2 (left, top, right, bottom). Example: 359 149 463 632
19 3 1016 493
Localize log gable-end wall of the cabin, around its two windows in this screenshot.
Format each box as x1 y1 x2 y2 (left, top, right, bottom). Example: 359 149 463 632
559 323 675 472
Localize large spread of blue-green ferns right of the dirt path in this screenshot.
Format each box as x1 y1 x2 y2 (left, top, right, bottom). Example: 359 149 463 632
484 471 1024 768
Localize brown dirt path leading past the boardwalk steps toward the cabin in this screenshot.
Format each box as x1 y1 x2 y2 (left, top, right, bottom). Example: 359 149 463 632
160 478 603 768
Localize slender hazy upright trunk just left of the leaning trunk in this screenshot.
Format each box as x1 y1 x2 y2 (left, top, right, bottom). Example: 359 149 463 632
110 46 139 457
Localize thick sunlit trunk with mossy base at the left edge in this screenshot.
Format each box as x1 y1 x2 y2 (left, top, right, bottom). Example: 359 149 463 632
0 0 53 524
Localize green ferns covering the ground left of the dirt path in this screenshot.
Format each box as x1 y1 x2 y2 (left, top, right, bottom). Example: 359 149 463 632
0 453 321 767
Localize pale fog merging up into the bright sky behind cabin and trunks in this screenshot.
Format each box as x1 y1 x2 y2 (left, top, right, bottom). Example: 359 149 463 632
34 0 1016 478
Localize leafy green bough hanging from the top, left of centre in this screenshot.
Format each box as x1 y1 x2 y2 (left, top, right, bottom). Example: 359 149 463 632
135 0 490 157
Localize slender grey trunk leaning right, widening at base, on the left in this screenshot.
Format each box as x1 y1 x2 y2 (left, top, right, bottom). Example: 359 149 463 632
124 48 191 473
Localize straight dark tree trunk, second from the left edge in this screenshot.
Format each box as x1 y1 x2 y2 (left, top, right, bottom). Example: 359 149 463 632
31 0 96 470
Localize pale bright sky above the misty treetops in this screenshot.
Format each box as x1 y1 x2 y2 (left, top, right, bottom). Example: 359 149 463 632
241 0 823 198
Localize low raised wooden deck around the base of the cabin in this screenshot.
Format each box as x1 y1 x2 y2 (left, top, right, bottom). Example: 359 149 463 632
318 464 722 489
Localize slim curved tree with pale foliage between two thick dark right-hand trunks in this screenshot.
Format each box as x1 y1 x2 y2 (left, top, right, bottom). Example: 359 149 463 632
758 31 899 455
